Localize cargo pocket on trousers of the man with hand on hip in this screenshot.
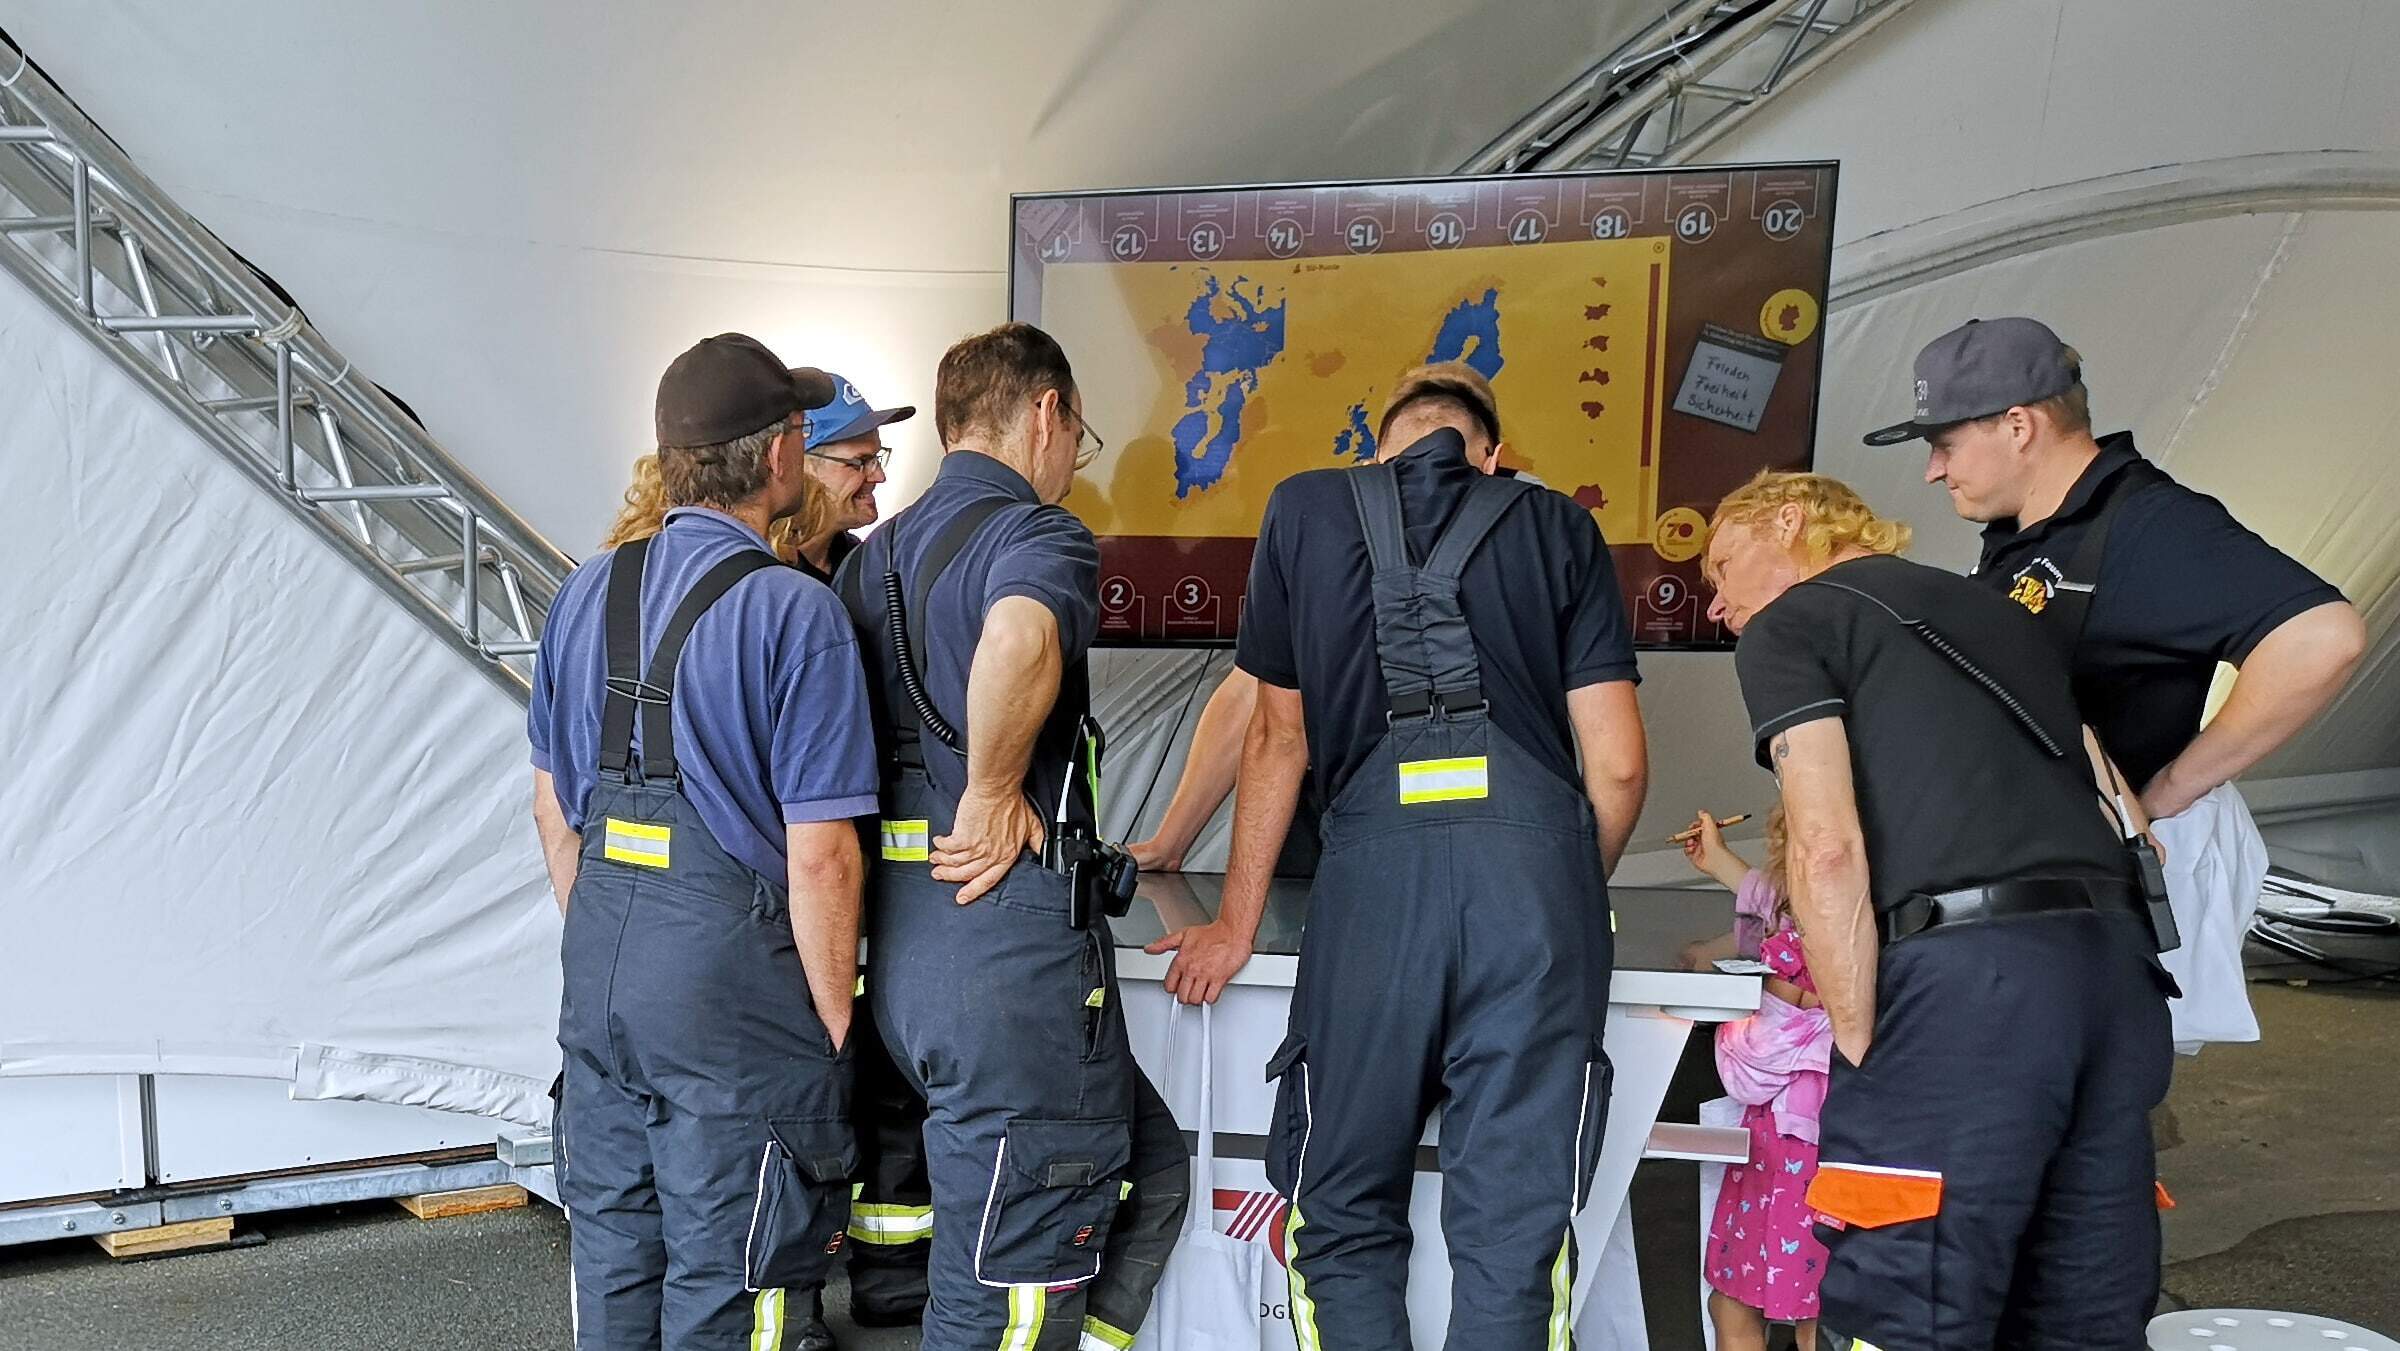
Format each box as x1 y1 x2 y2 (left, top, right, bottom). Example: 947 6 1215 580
974 1118 1133 1286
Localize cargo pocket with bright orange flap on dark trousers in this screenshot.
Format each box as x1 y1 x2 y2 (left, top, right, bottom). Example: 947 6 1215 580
1807 1164 1942 1339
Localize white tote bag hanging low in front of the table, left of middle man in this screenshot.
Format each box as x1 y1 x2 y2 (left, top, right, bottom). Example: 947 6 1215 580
1133 1003 1265 1351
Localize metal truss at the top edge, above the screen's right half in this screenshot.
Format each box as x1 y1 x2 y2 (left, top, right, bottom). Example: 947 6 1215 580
1459 0 1915 173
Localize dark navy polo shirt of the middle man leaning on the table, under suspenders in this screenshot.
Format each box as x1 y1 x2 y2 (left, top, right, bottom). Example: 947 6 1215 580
1234 430 1642 801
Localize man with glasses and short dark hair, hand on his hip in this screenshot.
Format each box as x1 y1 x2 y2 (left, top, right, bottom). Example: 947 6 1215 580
835 324 1190 1351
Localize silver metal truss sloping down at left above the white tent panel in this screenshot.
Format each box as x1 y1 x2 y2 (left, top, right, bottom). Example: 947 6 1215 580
0 41 571 698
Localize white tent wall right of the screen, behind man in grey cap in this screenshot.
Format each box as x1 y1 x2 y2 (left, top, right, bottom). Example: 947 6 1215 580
1644 0 2400 890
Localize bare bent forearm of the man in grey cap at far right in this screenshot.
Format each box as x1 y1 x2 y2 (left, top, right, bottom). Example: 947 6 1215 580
2141 600 2366 816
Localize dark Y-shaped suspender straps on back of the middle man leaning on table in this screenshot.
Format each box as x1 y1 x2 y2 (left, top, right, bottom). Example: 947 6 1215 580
1344 466 1531 722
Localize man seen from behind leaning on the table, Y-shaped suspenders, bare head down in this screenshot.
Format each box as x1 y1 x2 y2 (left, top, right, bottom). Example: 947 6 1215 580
1166 370 1646 1351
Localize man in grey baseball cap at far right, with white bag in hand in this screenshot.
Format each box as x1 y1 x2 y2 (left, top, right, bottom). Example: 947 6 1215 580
1867 319 2366 1051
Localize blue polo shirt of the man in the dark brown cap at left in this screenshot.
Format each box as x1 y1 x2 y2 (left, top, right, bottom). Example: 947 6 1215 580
526 506 876 883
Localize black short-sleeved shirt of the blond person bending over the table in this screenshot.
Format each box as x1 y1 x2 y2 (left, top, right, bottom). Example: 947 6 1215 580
1733 557 2124 909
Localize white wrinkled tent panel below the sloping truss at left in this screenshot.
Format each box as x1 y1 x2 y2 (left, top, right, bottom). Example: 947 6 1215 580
0 261 559 1123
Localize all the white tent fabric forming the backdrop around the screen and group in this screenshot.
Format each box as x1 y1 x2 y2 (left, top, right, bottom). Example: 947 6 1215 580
0 0 2400 1137
